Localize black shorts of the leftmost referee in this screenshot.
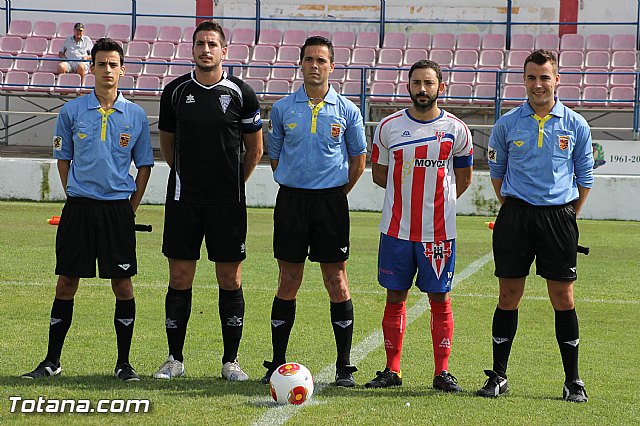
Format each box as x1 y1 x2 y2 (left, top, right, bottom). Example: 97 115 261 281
56 197 138 278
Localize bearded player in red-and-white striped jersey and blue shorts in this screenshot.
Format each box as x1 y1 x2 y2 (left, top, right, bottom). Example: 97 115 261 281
365 60 473 392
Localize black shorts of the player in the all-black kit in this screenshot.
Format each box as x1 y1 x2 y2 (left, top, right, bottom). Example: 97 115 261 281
162 199 247 262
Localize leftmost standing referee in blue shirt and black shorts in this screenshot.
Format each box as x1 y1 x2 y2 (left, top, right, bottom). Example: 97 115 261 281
22 38 153 381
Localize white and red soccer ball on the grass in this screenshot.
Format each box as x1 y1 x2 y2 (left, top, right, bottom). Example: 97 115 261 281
269 362 313 405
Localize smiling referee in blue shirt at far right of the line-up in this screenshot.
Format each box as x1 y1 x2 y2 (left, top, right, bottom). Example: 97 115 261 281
477 50 593 402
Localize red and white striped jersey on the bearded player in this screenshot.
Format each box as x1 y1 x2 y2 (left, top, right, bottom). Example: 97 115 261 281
371 109 473 242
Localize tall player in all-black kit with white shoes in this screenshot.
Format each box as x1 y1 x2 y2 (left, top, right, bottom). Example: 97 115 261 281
154 21 262 381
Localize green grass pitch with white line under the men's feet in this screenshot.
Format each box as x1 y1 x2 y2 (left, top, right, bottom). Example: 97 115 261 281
0 202 640 426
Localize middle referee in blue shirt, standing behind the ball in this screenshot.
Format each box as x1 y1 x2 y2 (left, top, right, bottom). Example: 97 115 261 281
262 37 367 387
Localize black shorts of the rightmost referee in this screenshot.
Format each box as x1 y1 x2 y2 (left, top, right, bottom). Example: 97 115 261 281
493 197 578 282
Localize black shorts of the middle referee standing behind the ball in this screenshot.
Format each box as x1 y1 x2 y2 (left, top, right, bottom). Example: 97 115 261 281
273 186 349 263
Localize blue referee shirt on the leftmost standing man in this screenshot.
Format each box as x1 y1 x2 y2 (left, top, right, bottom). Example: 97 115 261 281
53 92 153 200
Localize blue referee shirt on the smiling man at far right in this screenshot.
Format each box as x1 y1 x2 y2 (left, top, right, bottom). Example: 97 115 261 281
488 98 593 206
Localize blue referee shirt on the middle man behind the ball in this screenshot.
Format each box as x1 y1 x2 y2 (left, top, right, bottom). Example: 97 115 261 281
268 86 367 189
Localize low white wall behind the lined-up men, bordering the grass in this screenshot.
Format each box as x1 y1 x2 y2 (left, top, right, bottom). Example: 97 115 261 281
0 158 640 221
